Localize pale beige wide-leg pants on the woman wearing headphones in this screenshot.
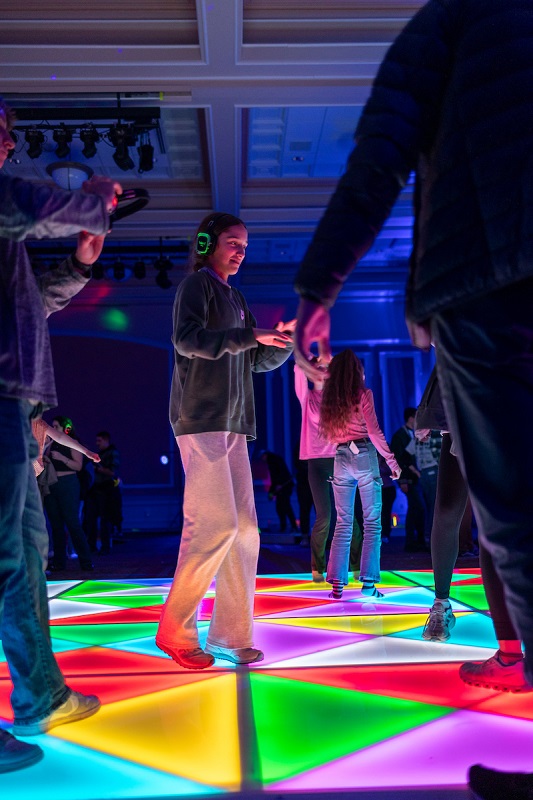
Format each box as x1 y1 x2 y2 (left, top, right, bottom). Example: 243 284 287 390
157 431 259 649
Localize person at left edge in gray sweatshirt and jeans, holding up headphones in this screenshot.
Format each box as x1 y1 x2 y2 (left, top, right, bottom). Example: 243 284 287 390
0 98 121 772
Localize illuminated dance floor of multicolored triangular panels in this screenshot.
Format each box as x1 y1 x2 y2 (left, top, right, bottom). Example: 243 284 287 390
0 569 533 800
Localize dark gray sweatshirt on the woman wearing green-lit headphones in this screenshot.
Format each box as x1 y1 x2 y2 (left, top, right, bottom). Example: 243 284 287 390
170 267 292 439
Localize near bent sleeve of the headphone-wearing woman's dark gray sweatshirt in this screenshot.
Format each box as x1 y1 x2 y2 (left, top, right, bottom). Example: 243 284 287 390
172 273 257 361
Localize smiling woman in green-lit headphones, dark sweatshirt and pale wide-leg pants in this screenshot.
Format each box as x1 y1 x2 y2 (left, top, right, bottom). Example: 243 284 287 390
156 213 295 669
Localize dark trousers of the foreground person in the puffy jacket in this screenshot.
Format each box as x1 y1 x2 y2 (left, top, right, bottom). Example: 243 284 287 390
431 278 533 683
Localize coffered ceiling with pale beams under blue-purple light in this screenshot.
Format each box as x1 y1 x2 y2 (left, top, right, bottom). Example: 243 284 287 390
0 0 422 292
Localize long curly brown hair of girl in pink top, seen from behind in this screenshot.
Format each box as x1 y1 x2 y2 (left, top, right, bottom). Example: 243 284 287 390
319 350 366 442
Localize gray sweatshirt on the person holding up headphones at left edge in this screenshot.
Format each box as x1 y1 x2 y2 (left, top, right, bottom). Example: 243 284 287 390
0 175 109 408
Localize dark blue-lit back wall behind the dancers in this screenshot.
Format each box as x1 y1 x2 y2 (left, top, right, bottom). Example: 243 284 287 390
46 281 433 528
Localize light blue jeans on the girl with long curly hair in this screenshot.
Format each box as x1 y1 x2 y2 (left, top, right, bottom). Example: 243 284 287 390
327 441 383 585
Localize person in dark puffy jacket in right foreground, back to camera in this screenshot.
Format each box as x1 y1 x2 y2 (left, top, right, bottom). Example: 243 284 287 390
295 0 533 798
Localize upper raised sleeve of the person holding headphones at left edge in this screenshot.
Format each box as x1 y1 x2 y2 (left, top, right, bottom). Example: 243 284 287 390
0 176 109 241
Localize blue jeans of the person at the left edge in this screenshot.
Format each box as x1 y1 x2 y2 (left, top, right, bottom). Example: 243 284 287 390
0 397 70 723
